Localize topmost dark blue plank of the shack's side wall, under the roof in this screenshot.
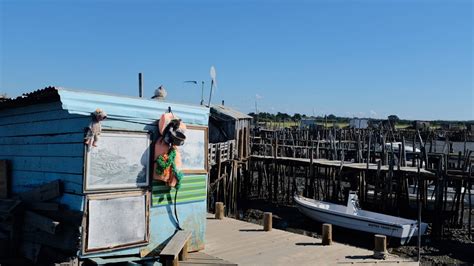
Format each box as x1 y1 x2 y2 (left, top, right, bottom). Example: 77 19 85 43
0 110 84 126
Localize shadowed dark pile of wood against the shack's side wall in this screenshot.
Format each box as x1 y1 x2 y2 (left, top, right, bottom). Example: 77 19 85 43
0 161 82 265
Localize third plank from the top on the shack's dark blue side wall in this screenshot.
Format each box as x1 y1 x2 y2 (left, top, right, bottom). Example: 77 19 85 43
0 132 85 145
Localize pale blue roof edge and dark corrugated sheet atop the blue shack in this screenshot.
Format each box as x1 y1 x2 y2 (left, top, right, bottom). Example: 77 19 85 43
0 87 209 125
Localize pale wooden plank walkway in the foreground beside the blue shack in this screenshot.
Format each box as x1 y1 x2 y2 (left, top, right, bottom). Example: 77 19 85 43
203 214 418 266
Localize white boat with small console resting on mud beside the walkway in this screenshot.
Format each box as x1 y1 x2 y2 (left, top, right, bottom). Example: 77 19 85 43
294 192 428 245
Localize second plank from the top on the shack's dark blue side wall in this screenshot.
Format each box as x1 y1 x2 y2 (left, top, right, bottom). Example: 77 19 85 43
0 117 91 137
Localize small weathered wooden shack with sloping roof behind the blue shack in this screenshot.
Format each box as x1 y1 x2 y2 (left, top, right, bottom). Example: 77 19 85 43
209 105 252 161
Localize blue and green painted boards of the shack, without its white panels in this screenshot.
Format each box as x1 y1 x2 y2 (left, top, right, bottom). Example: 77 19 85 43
0 89 209 257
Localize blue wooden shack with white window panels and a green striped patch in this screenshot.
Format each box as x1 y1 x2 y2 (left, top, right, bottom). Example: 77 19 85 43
0 87 209 258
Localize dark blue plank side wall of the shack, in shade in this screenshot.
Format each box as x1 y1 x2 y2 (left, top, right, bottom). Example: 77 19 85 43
0 102 90 210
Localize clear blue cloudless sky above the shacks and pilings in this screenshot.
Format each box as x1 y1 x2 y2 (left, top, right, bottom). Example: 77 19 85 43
0 0 474 120
